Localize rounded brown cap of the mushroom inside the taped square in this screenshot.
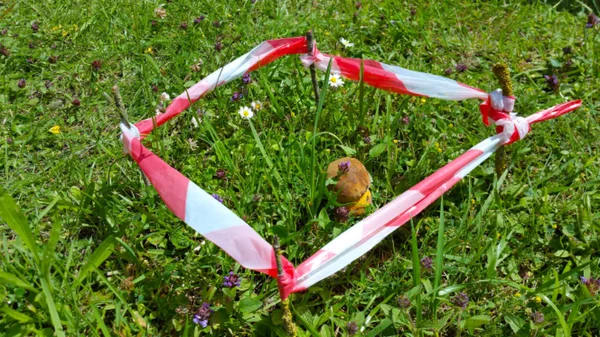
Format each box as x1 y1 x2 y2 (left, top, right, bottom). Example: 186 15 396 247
327 157 371 203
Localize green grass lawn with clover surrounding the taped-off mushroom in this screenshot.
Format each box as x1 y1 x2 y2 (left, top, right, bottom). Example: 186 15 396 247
0 0 600 337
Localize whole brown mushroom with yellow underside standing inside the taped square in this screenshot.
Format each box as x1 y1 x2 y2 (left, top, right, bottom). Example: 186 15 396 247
327 157 372 215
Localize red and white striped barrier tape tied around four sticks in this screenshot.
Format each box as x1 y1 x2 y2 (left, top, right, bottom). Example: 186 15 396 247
121 37 581 298
